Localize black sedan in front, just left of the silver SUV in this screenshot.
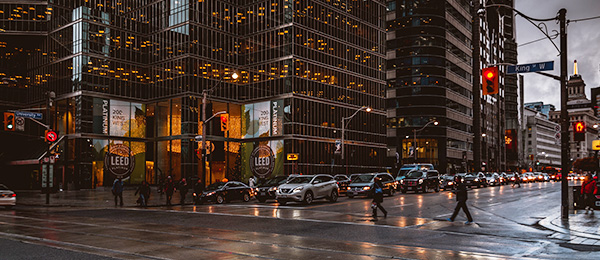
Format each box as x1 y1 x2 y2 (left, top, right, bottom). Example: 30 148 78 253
200 181 253 204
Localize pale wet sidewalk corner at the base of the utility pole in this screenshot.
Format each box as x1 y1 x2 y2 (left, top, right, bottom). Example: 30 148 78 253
539 210 600 246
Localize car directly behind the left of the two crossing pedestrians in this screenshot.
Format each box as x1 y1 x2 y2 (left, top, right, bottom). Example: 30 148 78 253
346 172 397 198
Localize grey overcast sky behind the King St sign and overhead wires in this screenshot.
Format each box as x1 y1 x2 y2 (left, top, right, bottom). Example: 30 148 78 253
515 0 600 107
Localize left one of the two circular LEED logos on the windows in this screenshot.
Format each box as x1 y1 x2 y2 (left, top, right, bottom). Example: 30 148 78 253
104 144 135 178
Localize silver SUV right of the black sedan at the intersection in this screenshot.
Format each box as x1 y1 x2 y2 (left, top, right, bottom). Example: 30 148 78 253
275 174 339 205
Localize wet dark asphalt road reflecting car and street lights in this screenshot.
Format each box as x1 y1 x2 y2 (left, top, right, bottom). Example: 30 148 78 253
0 182 600 259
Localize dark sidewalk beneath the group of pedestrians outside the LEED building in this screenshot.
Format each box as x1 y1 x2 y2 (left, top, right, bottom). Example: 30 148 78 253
16 187 193 207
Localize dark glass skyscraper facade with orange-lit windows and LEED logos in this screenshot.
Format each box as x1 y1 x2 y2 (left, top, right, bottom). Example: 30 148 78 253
0 0 386 190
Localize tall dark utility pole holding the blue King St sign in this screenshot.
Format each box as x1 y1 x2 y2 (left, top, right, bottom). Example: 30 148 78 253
558 8 570 219
